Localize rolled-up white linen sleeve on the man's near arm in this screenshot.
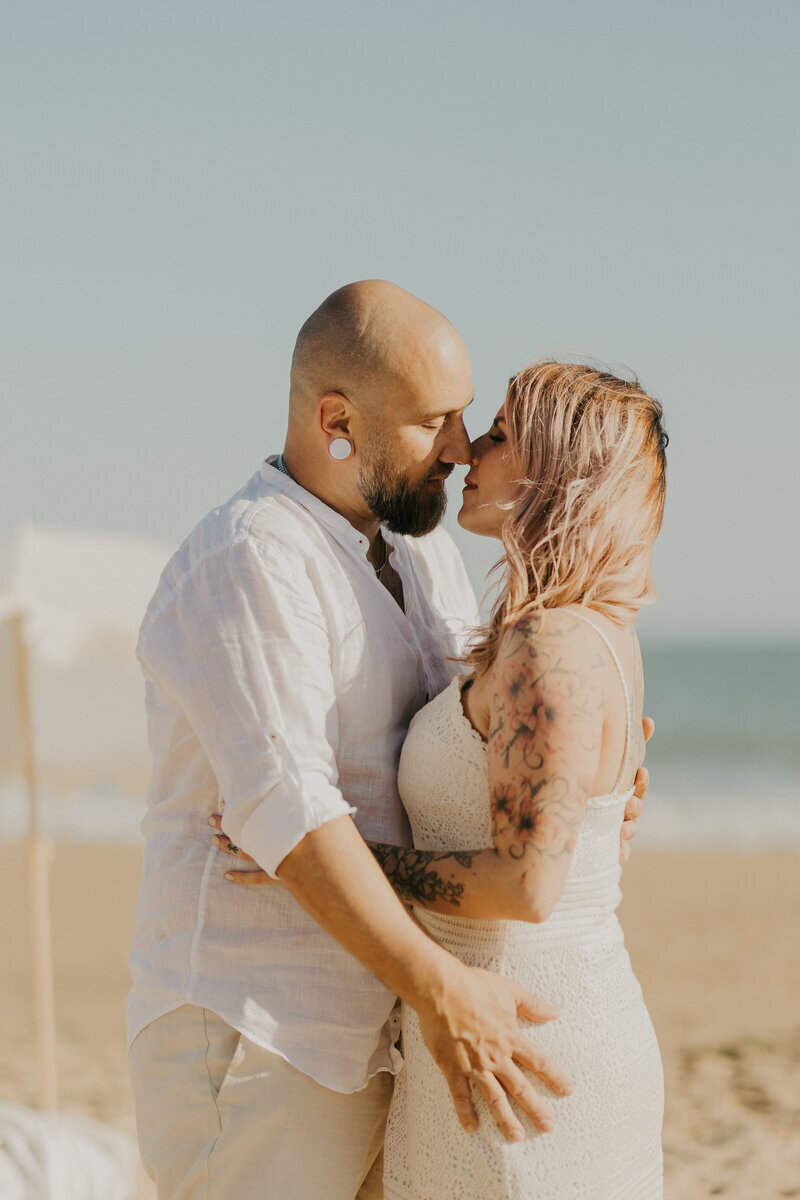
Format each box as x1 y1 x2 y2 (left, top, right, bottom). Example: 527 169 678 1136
138 539 355 876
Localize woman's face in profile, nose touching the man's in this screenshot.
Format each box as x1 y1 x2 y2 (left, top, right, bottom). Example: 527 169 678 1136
458 404 521 538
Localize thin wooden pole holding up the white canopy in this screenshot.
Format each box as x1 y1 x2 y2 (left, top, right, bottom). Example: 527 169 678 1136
13 613 59 1109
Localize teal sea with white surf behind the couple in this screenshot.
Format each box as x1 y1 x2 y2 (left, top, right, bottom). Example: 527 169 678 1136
0 644 800 850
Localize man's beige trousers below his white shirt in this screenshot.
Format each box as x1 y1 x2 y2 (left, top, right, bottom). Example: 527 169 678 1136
130 1004 393 1200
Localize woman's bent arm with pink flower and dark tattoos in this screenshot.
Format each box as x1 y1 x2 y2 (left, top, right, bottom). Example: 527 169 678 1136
369 612 607 922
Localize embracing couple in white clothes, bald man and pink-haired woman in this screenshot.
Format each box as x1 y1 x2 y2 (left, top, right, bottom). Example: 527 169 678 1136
128 281 666 1200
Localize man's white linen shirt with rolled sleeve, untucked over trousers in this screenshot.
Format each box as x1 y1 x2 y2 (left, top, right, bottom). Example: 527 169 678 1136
127 460 476 1092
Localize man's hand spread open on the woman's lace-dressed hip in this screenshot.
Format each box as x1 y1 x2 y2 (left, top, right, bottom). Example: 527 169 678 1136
417 960 572 1141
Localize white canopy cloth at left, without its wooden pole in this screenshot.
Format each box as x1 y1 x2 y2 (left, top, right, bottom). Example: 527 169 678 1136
0 521 172 791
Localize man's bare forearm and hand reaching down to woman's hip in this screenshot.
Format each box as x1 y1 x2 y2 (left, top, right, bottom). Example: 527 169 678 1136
277 818 570 1141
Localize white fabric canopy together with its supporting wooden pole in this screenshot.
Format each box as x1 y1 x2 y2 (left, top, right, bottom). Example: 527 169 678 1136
0 521 170 1108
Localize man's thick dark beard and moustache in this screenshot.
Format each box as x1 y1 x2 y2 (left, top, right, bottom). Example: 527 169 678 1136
359 448 452 538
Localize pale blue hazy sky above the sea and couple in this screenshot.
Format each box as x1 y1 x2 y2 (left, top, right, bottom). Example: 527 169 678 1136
0 0 800 642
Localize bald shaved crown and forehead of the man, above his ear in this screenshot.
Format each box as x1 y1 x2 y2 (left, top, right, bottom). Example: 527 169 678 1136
290 280 469 418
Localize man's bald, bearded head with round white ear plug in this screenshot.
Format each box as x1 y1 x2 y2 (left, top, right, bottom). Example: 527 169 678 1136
283 280 473 544
